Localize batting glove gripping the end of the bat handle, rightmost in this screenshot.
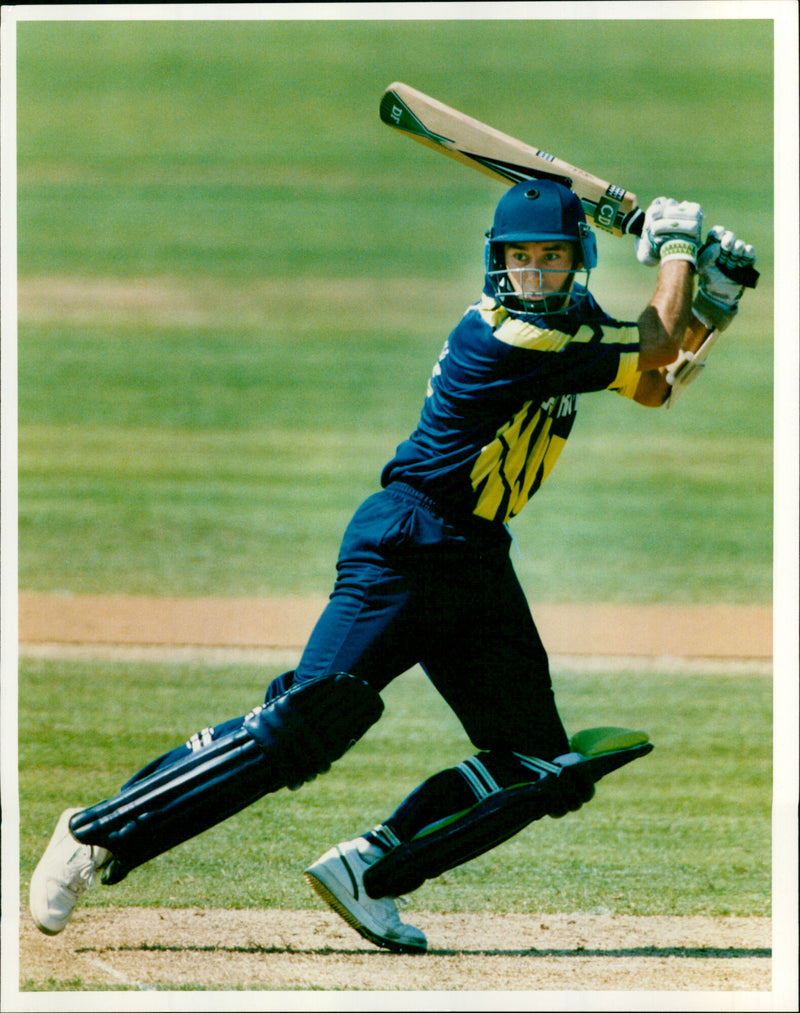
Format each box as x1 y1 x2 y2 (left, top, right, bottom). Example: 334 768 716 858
692 225 755 330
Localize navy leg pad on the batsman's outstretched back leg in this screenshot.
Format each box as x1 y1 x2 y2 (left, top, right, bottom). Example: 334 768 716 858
70 673 383 883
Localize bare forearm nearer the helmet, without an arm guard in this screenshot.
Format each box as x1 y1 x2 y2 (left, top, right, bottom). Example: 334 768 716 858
638 260 694 374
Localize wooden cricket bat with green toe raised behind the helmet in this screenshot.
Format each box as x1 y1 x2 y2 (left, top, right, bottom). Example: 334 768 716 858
380 81 758 288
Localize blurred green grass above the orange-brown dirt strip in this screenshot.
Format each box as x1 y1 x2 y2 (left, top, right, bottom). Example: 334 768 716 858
17 20 774 602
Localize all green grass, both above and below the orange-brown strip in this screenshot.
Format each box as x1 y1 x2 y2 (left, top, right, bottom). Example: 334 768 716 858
10 19 774 931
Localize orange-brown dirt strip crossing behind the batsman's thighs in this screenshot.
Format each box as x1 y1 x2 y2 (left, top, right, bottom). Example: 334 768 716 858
19 593 773 664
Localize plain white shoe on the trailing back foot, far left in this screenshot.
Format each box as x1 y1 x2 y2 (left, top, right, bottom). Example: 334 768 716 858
30 809 111 936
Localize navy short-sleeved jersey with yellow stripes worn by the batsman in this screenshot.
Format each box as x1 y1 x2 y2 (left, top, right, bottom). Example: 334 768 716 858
382 287 639 522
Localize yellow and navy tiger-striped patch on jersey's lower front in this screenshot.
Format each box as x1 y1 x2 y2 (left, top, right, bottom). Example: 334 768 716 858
470 398 566 521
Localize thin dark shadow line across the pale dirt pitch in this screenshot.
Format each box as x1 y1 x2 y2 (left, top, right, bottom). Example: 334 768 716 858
81 943 773 960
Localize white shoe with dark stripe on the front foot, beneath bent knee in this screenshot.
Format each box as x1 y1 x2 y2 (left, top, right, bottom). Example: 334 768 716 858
305 837 427 953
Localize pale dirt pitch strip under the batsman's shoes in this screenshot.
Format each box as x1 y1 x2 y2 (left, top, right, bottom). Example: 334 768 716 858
15 908 771 992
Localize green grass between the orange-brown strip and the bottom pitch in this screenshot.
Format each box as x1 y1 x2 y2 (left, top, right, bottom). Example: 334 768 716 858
20 660 772 916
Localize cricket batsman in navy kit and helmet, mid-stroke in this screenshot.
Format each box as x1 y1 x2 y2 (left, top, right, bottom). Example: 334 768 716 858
30 179 755 953
